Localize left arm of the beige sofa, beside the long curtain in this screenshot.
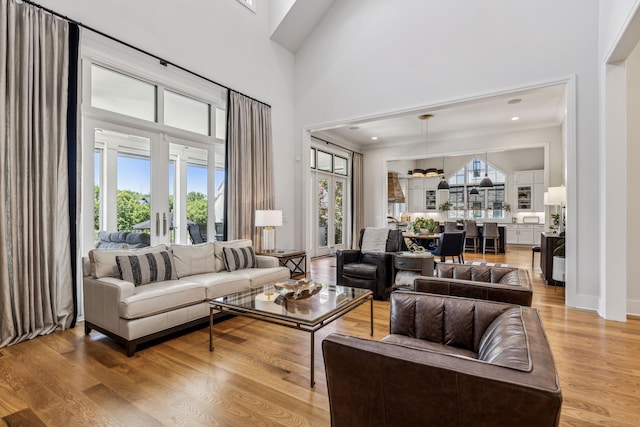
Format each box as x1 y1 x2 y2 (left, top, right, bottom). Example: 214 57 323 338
82 276 135 335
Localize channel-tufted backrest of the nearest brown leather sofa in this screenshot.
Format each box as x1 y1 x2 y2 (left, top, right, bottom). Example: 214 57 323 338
390 292 513 353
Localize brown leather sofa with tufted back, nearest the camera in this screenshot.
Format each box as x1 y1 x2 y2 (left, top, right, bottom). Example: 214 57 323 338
322 291 562 427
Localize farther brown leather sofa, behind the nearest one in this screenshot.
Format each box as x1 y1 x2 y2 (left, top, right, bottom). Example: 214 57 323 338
413 263 533 306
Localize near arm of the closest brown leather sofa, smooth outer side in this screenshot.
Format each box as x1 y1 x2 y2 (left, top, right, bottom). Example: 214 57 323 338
322 333 562 427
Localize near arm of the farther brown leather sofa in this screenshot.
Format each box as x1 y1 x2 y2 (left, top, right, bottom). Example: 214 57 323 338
413 276 533 307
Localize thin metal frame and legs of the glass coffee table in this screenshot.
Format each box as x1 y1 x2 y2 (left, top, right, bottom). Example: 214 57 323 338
209 293 373 387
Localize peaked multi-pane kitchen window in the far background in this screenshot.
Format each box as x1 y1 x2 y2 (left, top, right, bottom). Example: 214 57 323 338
449 157 505 219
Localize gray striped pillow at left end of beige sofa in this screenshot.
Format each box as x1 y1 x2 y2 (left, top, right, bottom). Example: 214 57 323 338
116 251 178 286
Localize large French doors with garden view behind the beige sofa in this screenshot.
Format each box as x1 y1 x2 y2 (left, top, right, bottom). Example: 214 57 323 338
83 119 215 248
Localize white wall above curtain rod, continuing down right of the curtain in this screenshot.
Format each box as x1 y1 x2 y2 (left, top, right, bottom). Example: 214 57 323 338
38 0 299 247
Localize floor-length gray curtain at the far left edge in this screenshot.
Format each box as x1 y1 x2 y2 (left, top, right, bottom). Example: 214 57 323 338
0 0 74 347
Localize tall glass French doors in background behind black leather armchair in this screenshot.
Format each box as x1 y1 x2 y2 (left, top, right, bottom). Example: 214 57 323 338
312 172 347 256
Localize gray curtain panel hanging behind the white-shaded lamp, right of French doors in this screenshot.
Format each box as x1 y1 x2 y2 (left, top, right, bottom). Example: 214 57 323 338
227 91 274 248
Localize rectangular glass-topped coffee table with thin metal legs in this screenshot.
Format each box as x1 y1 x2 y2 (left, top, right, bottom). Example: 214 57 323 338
209 285 373 387
